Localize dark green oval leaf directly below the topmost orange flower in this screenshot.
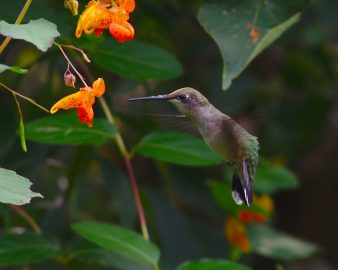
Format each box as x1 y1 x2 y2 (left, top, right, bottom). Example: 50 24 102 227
88 39 182 80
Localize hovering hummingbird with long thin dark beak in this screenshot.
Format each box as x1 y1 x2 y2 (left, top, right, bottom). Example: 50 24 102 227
128 87 259 206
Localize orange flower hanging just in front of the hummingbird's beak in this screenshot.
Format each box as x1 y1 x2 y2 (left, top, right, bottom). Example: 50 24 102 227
50 78 106 127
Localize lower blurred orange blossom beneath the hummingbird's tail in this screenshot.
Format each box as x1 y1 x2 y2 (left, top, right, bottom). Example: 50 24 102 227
224 217 251 253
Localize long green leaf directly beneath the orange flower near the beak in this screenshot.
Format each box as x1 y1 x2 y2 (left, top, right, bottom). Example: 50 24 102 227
26 112 116 145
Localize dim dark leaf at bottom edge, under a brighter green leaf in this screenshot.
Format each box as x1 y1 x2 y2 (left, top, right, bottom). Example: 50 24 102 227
71 247 148 270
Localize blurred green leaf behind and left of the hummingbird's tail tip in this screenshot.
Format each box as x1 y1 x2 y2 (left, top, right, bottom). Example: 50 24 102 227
208 180 266 215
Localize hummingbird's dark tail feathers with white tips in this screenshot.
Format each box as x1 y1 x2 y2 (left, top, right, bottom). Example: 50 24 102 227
232 160 252 206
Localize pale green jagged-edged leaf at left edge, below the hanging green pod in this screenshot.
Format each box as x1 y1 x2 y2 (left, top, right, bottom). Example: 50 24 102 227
0 168 43 205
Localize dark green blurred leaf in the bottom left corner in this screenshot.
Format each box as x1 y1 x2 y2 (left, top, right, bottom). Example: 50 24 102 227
0 233 60 265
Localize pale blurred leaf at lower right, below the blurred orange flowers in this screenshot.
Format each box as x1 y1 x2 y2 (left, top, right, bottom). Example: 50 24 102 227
249 225 320 261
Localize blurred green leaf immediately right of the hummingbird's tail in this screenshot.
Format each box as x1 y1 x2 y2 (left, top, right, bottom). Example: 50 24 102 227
253 158 298 193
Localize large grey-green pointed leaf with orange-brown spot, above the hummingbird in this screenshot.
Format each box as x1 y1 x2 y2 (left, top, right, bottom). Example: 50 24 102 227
198 0 309 90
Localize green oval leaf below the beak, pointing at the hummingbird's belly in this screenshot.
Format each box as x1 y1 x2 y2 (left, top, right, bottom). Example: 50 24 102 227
135 132 221 166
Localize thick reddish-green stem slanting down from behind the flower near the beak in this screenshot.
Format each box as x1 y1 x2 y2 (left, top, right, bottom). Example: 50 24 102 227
98 97 150 240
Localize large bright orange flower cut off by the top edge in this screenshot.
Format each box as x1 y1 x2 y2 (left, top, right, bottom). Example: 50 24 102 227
75 0 135 43
